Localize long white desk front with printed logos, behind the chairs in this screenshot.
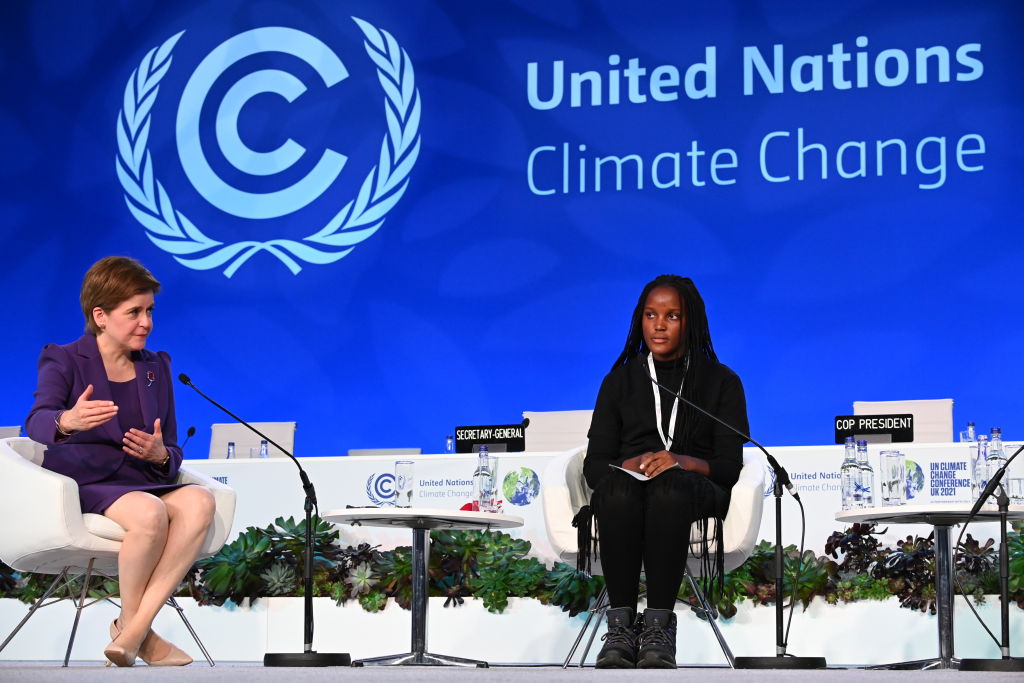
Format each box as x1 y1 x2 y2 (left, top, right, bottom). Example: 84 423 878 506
188 443 1009 563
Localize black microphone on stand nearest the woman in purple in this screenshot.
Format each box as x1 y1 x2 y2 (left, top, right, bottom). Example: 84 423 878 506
178 373 352 667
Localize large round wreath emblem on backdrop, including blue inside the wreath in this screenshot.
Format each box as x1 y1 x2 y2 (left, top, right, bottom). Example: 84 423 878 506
115 16 420 278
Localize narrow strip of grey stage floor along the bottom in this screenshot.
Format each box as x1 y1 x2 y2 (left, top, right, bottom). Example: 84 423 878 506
0 661 1021 683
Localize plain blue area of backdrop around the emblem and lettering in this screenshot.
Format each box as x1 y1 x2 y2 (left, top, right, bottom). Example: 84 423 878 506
0 0 1024 457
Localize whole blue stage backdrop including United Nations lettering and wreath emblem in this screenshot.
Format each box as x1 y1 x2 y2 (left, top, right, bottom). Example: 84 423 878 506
0 0 1024 457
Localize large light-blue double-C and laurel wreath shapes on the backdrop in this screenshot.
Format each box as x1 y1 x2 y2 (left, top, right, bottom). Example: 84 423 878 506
116 21 420 278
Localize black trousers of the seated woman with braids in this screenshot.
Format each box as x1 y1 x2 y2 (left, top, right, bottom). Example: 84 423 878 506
591 468 729 609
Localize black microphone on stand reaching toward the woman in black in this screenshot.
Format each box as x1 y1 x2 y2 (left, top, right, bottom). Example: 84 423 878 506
637 362 827 669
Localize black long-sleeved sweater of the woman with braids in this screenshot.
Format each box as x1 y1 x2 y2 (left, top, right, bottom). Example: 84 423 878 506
584 357 750 492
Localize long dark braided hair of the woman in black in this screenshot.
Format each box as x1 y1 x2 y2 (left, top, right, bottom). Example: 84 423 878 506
612 275 718 453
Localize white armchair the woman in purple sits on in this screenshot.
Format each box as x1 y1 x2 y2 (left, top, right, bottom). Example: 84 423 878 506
0 437 234 667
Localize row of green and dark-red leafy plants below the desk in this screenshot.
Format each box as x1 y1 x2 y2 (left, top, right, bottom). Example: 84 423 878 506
0 517 1024 618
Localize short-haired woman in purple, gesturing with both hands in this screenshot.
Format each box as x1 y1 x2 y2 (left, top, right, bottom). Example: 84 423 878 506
26 256 215 667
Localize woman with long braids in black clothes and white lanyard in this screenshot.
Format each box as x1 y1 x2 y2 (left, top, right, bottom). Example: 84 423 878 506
584 275 748 669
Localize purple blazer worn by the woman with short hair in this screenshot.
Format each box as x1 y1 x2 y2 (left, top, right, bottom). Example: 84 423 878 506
25 333 182 484
